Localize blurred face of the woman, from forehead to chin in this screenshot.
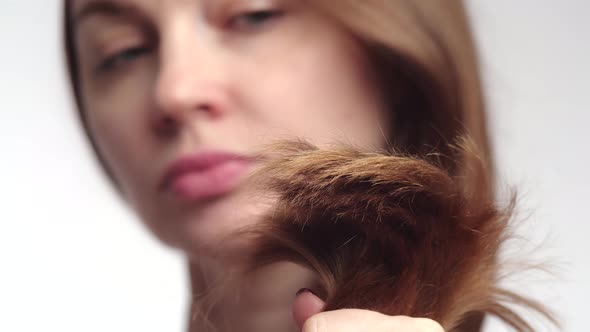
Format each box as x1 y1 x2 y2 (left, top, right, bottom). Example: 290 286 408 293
70 0 388 255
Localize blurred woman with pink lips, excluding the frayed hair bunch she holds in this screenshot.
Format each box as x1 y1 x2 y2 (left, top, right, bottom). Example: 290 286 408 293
66 0 500 332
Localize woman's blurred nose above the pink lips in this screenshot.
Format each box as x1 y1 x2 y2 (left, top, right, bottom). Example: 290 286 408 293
152 25 228 136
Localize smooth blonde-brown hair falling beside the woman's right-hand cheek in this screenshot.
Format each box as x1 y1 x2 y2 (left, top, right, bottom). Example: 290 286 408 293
309 0 492 192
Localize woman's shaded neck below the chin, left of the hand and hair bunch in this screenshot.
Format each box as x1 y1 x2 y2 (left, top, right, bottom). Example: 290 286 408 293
189 255 315 332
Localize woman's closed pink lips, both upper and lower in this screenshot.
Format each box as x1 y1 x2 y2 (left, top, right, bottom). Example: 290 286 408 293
160 151 253 202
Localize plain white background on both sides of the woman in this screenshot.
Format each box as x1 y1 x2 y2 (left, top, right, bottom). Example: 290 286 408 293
0 0 590 332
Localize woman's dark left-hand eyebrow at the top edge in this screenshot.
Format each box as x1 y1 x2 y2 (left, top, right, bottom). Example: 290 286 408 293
73 0 146 26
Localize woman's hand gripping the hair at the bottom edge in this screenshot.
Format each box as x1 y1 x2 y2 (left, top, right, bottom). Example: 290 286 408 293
293 291 444 332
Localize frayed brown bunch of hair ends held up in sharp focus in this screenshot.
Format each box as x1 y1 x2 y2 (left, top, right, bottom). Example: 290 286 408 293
243 140 558 332
